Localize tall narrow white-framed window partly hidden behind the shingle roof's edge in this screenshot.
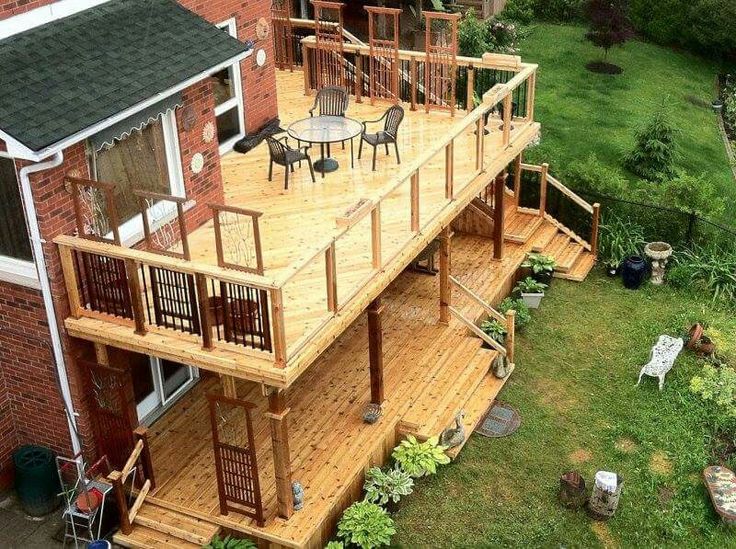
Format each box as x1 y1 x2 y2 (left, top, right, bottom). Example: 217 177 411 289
212 19 245 154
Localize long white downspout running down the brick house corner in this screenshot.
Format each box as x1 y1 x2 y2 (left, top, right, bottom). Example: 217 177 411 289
18 152 82 455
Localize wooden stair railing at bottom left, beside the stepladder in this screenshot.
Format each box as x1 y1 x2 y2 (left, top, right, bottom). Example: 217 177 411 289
107 426 156 535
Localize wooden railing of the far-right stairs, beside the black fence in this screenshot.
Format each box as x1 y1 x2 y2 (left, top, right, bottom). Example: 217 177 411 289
512 159 600 256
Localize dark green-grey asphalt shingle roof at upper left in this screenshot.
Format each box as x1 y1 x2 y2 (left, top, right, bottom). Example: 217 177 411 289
0 0 247 151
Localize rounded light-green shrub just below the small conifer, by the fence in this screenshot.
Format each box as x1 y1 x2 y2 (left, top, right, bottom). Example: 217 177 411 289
659 170 725 217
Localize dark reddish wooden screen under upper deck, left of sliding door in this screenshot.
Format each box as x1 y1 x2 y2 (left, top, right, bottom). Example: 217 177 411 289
85 359 138 469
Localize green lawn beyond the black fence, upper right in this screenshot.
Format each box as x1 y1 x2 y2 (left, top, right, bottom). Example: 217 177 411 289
521 24 736 219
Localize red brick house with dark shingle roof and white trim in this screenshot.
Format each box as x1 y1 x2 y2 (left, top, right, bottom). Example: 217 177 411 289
0 0 277 487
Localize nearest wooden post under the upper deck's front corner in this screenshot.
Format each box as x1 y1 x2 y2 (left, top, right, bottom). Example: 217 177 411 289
266 389 294 519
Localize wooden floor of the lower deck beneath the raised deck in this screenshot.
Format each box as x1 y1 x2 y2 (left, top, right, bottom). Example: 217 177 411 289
121 222 568 547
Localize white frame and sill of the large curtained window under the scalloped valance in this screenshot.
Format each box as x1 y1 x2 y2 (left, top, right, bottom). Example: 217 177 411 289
94 109 191 246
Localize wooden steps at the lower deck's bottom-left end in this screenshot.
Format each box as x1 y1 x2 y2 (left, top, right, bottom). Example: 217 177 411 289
113 501 220 549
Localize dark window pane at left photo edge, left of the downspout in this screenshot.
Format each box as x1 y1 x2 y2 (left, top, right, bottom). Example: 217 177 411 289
0 157 33 261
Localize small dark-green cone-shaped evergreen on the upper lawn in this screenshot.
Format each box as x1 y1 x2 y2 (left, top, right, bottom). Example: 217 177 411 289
624 104 678 181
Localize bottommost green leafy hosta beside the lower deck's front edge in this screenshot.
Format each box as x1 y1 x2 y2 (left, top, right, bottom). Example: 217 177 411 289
337 501 396 549
